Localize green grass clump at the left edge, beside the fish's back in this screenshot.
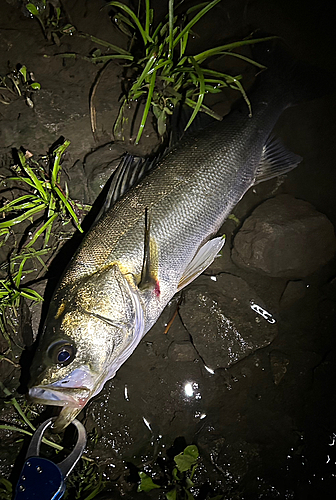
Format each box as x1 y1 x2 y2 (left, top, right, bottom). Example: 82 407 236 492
0 141 90 340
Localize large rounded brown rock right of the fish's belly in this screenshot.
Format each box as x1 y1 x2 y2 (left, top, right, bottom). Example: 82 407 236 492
232 194 336 279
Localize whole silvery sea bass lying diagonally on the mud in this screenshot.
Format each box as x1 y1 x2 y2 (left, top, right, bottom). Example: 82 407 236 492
29 40 314 430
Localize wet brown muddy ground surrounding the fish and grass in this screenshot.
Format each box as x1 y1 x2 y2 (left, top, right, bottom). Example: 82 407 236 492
0 0 336 500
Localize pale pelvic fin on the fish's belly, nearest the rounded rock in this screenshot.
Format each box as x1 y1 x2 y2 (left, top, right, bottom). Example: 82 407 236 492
177 236 225 291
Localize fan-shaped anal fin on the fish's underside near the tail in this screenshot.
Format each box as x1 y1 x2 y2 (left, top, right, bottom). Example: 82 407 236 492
254 136 302 184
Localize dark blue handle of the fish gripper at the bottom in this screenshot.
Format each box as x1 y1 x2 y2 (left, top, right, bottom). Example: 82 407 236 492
14 457 65 500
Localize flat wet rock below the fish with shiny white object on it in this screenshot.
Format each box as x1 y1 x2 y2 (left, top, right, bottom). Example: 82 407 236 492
180 273 278 369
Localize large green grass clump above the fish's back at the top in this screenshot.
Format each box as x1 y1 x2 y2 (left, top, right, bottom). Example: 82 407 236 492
108 0 267 144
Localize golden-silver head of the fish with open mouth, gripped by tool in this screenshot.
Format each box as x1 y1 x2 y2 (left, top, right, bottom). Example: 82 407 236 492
28 264 144 431
